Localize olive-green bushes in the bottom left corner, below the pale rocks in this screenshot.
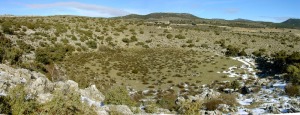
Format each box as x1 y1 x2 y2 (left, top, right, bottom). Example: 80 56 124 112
0 85 96 115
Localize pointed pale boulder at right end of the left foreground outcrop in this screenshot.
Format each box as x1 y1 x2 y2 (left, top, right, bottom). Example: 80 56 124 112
80 85 105 102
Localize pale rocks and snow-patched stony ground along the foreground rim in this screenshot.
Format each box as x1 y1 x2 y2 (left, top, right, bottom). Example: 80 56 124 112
0 58 300 115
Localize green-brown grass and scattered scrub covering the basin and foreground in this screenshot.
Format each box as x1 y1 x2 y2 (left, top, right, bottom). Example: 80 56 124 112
0 14 300 114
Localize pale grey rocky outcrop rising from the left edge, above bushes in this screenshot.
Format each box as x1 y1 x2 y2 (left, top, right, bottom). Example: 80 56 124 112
0 64 105 106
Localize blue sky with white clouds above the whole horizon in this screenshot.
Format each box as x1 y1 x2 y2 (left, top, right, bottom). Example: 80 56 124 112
0 0 300 22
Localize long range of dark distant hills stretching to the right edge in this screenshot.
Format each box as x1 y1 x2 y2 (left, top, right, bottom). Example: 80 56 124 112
114 13 300 29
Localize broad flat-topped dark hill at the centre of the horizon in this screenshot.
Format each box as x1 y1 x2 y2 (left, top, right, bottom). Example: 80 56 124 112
116 13 200 20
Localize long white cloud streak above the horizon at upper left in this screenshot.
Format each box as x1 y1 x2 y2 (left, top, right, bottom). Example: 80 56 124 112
26 2 130 17
